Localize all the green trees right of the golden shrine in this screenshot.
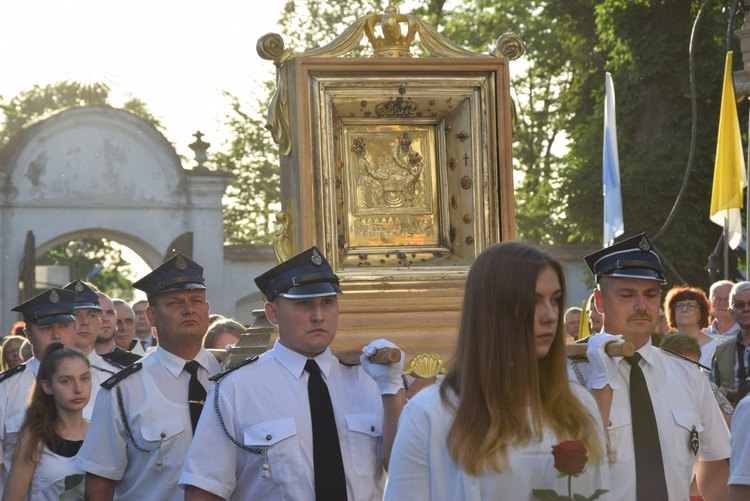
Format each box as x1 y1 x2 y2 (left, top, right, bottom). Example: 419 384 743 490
420 0 747 286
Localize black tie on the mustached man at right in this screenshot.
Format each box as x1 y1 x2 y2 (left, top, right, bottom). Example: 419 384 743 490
625 353 668 501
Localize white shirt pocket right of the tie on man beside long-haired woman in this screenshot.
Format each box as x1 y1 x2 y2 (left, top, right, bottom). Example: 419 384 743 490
346 413 383 477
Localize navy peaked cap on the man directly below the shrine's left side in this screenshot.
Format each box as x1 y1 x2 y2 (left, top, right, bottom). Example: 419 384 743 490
255 247 341 301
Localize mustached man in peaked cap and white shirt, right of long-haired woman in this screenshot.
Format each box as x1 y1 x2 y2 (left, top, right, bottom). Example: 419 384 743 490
585 233 730 501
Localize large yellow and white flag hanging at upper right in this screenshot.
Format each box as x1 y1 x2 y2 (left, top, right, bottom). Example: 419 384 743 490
710 51 745 249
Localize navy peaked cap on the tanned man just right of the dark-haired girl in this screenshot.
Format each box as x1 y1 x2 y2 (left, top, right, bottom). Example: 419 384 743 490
133 253 206 298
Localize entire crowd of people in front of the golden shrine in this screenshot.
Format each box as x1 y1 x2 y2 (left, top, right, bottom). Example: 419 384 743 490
0 234 750 501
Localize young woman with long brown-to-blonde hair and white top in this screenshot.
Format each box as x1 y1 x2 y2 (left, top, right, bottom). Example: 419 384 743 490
385 241 609 501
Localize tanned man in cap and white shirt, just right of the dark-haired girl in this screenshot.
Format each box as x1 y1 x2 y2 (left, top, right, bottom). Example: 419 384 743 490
76 254 221 501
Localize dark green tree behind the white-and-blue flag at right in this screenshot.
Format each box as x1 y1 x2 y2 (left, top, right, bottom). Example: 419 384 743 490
560 0 743 287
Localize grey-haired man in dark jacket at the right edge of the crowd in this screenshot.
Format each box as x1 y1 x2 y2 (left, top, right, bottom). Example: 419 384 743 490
711 282 750 405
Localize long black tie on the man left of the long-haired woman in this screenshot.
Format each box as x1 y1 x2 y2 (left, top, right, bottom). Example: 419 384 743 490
305 359 346 501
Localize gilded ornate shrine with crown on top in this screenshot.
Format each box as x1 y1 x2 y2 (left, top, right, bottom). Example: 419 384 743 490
257 0 524 358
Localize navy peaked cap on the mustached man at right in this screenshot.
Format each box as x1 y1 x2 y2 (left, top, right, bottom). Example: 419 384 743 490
583 233 667 284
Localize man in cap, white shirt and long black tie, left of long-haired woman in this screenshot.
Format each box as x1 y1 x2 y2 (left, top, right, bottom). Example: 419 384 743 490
180 247 406 501
